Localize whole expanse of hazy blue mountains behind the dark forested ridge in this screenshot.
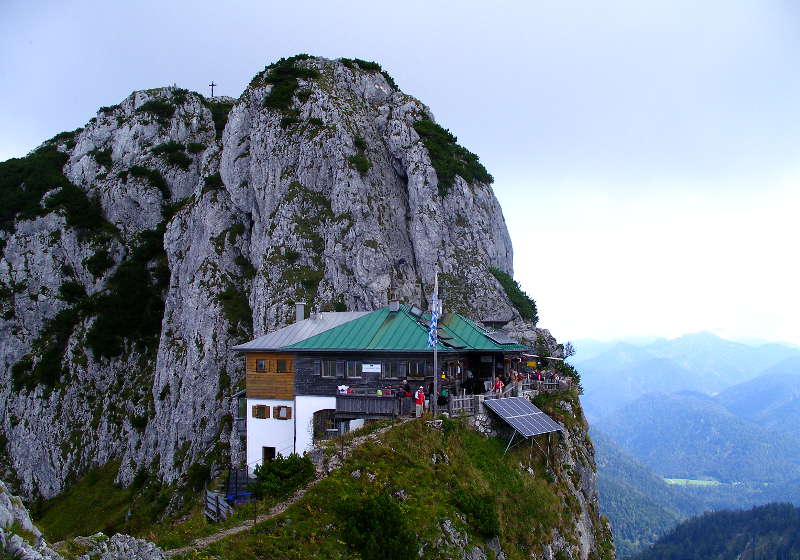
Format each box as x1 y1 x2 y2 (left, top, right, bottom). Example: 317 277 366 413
572 333 800 558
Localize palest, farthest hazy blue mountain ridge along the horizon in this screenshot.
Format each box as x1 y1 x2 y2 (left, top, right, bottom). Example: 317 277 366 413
571 332 800 421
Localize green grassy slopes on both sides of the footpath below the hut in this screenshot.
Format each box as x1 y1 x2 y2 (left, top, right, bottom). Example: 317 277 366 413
28 394 611 560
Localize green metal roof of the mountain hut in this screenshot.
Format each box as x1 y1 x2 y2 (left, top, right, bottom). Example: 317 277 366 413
283 305 527 352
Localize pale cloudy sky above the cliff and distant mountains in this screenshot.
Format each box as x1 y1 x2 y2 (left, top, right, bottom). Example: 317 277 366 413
0 0 800 343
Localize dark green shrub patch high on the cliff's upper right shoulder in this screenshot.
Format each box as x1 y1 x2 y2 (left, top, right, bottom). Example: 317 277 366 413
414 119 494 197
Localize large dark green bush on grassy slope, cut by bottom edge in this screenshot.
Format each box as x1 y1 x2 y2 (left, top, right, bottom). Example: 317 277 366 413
337 492 417 560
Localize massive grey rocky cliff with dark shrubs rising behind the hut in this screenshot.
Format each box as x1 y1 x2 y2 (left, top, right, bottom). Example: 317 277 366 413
0 56 532 499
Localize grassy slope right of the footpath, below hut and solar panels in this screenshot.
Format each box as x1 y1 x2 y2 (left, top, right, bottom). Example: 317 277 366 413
178 390 611 560
